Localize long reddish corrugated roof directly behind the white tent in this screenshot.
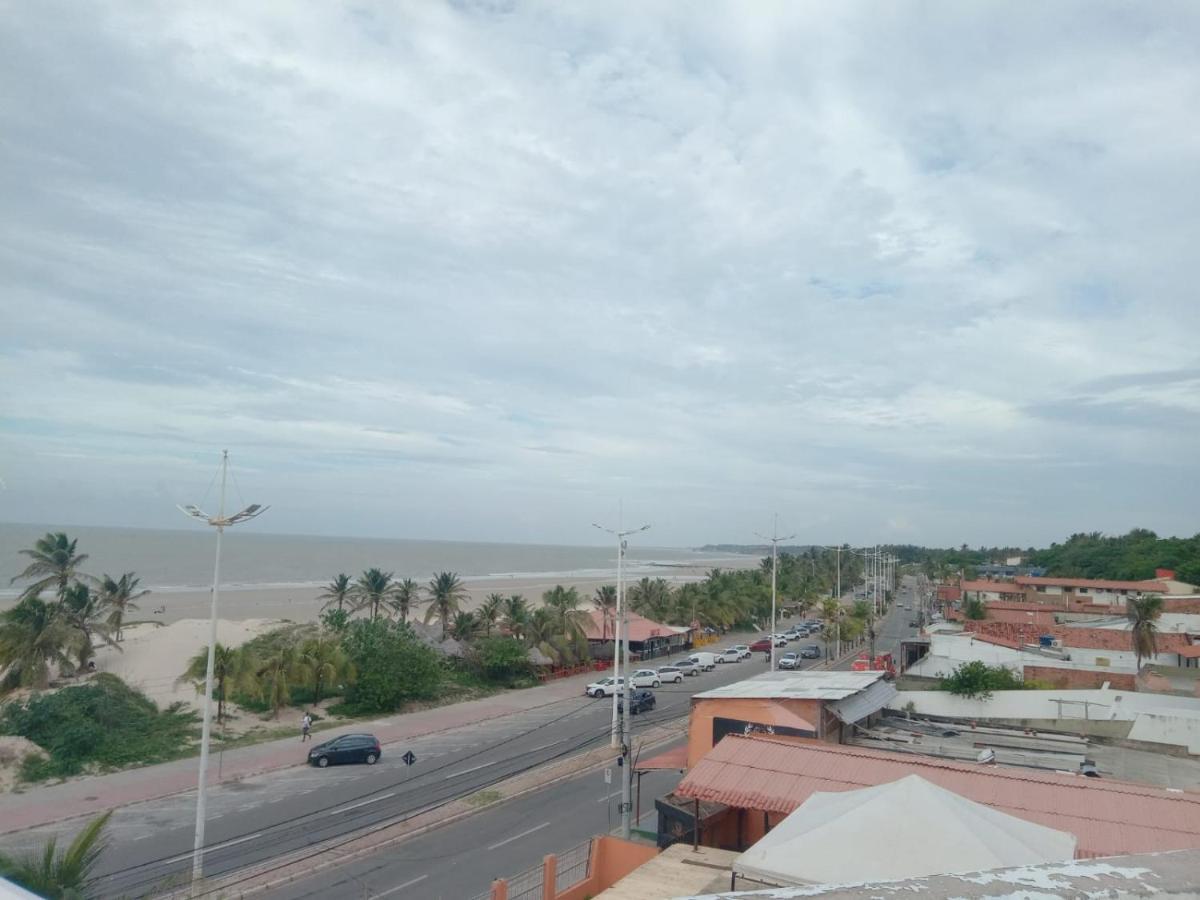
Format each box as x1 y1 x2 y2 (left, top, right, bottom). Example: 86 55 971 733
676 736 1200 857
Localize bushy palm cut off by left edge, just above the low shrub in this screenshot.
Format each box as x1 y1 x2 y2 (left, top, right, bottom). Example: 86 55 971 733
0 594 76 690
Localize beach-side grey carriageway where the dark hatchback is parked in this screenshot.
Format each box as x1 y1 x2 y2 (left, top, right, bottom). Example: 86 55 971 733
9 641 782 896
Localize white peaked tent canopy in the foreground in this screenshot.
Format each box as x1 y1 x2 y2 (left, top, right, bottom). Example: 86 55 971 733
733 775 1075 884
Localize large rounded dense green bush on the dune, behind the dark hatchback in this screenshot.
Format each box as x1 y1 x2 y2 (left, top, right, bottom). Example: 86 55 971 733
341 619 443 714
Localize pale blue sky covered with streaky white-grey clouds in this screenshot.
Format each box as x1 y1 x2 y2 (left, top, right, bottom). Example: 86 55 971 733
0 0 1200 546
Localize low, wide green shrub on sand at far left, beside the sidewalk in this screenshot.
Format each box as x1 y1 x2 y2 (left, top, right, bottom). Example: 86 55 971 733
0 673 198 781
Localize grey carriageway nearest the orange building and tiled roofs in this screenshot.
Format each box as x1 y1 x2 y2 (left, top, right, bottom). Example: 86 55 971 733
264 586 914 900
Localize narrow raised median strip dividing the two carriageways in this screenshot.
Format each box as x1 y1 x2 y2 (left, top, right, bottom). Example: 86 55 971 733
156 716 686 900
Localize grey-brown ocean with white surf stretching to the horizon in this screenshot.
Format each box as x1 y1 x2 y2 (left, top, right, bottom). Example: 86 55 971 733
0 523 745 598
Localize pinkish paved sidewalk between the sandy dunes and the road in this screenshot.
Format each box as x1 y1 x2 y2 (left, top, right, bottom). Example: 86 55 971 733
0 672 602 834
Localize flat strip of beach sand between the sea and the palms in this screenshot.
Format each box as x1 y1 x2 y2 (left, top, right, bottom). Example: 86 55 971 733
132 559 757 624
